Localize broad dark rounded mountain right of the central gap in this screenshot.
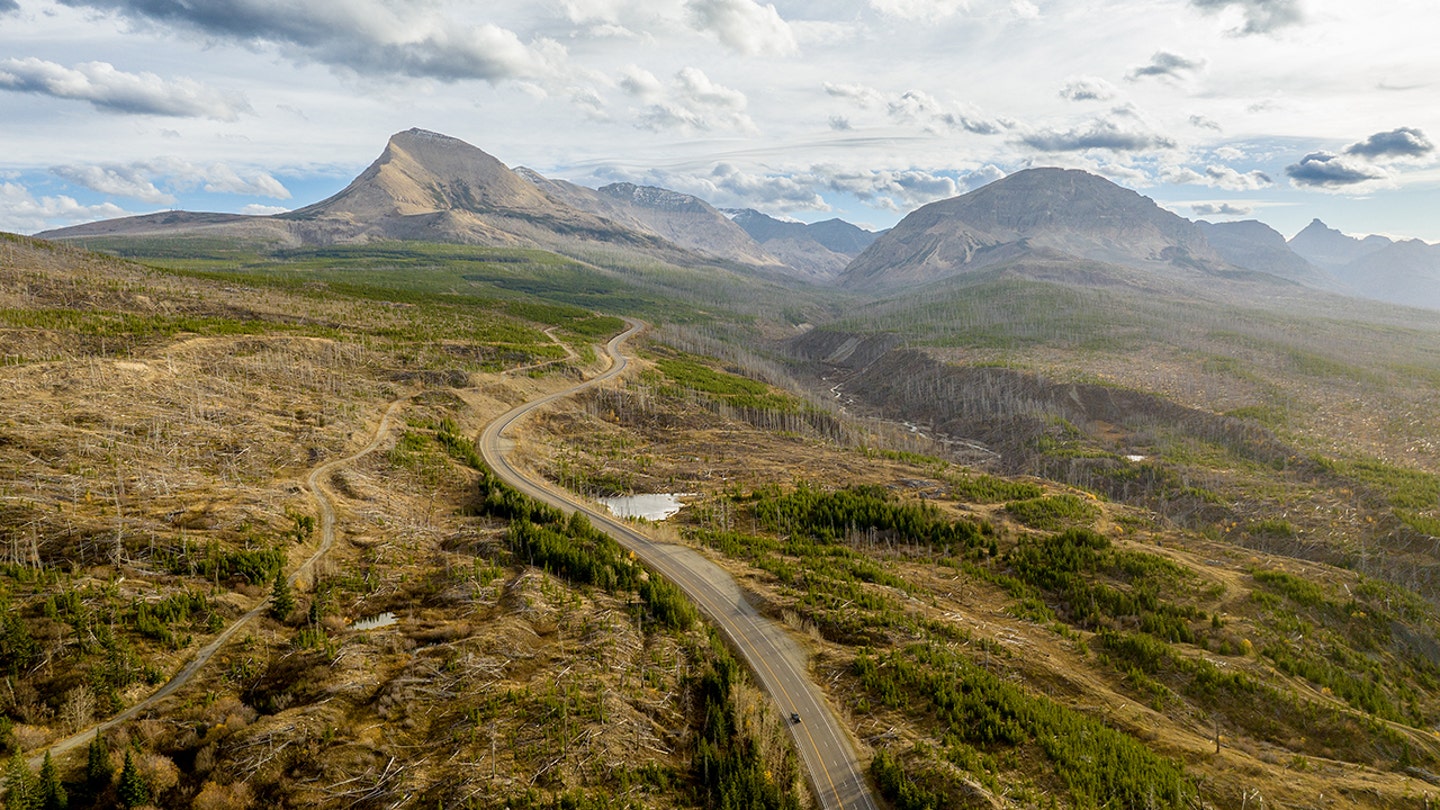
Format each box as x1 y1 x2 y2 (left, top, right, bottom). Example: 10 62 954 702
840 169 1225 288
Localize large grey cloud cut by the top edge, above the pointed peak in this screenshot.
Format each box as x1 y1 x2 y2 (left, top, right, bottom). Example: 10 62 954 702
59 0 564 82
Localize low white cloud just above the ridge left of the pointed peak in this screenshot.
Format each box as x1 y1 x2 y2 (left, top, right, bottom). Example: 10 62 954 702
50 157 291 205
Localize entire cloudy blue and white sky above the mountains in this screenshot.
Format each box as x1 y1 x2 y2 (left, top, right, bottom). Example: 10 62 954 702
0 0 1440 242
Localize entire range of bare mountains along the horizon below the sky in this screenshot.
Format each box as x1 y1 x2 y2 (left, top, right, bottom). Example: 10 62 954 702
40 130 1440 308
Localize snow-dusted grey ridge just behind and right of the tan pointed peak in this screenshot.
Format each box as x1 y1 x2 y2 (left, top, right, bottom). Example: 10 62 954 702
516 167 788 270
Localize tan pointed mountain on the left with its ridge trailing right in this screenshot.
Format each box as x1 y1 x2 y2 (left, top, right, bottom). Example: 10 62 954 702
45 130 789 274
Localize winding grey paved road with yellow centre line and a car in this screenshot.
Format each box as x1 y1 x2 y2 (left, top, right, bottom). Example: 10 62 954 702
480 320 878 810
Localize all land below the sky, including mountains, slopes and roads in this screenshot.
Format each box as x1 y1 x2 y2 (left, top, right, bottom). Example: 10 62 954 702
0 130 1440 810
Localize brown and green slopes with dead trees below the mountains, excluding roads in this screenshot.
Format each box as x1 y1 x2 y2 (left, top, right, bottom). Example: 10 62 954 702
8 229 1440 809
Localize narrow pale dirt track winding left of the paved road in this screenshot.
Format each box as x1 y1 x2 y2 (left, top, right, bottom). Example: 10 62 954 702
29 401 402 768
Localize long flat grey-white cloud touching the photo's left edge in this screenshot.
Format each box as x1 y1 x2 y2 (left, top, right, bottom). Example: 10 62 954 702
0 56 251 121
